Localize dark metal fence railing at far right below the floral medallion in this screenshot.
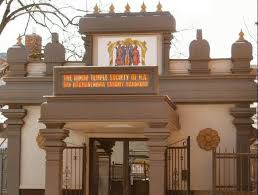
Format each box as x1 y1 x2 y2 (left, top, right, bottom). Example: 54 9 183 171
212 150 258 193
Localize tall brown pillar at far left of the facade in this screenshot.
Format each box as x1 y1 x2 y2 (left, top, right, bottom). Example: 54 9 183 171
1 105 26 195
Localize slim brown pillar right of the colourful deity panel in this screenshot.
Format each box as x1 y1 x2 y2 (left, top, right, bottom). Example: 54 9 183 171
161 32 173 75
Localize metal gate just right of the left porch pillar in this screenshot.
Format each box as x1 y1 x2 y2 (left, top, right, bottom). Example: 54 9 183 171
63 146 86 195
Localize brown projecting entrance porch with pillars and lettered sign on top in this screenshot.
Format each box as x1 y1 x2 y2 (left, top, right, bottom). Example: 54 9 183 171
39 66 179 195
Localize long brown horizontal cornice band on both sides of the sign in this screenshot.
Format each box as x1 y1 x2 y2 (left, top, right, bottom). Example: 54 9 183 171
0 74 257 105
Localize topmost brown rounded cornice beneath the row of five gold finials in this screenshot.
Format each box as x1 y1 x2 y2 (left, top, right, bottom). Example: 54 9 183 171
79 12 176 34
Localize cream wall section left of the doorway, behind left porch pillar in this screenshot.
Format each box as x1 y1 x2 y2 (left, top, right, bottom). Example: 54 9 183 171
20 106 85 189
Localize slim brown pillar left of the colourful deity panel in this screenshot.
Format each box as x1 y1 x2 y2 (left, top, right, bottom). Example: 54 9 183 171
82 34 93 66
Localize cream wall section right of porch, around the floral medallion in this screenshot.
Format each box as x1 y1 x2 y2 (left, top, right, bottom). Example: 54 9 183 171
169 104 236 190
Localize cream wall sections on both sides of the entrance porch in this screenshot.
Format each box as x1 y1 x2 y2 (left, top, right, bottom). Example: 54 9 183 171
20 104 236 190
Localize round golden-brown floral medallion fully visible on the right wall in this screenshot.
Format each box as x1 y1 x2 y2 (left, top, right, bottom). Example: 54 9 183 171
197 128 220 151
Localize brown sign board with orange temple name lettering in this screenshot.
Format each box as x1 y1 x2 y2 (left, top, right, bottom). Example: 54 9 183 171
53 66 159 95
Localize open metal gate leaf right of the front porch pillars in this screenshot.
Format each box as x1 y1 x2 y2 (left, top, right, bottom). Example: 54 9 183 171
165 137 190 195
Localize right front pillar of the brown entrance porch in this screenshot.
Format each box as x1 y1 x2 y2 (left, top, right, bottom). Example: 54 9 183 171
144 124 170 195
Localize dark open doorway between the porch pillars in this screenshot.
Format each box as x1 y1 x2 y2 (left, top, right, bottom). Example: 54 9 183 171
90 138 149 195
